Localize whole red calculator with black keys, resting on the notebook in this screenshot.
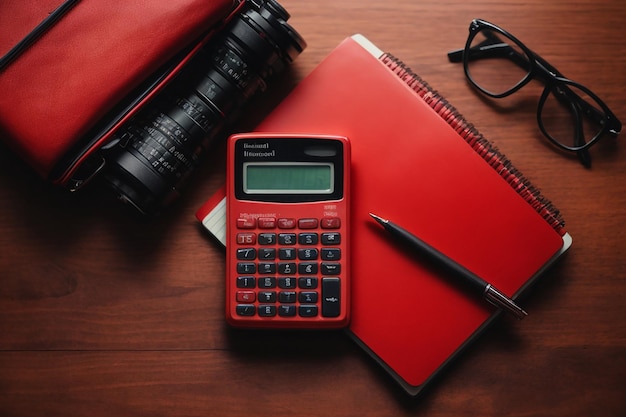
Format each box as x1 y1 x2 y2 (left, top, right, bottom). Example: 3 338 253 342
226 133 350 328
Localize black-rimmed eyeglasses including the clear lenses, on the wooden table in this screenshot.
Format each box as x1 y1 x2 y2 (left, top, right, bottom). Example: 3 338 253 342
448 19 622 167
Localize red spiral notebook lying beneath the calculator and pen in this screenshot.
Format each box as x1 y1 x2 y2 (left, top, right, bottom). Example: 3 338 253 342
197 35 571 395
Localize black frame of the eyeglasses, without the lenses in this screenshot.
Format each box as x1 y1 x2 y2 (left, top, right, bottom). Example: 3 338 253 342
448 19 622 167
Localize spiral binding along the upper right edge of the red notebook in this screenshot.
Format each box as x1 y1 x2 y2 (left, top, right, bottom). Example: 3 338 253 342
380 53 565 235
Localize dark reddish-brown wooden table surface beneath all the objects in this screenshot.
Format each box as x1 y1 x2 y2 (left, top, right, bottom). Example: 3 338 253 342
0 0 626 417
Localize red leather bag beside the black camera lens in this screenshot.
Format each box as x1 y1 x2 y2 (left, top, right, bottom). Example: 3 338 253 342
0 0 243 187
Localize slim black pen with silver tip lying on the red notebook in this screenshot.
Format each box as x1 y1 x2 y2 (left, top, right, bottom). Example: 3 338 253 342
370 213 528 320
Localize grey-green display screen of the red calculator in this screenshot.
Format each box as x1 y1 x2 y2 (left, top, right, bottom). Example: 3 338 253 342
243 162 335 194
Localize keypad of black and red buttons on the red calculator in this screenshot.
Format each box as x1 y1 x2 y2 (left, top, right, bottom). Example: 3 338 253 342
234 217 342 319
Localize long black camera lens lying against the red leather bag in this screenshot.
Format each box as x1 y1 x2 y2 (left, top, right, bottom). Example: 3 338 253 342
104 0 306 214
